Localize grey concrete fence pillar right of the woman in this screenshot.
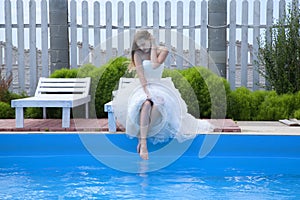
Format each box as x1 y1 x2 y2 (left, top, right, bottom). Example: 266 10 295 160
208 0 227 78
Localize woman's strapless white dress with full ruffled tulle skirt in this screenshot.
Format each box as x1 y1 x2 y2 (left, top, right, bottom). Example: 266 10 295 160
112 60 213 144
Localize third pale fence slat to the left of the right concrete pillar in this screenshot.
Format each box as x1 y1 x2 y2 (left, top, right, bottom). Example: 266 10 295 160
176 1 183 69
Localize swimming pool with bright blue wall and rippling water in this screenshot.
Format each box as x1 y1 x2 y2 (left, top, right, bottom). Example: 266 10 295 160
0 133 300 200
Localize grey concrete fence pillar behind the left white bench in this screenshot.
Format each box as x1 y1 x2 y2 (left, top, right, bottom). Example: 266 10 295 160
49 0 70 73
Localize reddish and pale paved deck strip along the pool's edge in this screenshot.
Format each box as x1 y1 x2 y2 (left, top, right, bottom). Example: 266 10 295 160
0 118 300 135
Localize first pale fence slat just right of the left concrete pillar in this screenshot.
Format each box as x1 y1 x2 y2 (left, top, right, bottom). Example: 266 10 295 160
70 0 77 68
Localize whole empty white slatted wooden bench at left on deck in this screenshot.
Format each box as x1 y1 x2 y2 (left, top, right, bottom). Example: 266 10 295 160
11 77 91 128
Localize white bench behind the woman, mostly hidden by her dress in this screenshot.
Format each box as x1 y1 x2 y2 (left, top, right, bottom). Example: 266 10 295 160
104 77 171 132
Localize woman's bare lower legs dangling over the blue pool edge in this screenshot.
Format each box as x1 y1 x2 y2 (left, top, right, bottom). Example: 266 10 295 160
138 100 152 160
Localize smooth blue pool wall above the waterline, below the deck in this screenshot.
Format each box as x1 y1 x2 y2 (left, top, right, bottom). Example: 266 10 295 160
0 133 300 158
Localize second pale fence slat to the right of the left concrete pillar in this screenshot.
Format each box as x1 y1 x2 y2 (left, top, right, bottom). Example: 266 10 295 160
79 1 89 64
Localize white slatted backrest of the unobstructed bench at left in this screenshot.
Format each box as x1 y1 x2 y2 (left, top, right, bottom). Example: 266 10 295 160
35 77 91 96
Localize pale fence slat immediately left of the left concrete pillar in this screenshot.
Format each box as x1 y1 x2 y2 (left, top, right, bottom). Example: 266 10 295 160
41 0 49 77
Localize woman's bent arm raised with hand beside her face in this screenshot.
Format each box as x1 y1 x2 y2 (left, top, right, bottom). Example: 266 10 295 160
150 36 169 68
